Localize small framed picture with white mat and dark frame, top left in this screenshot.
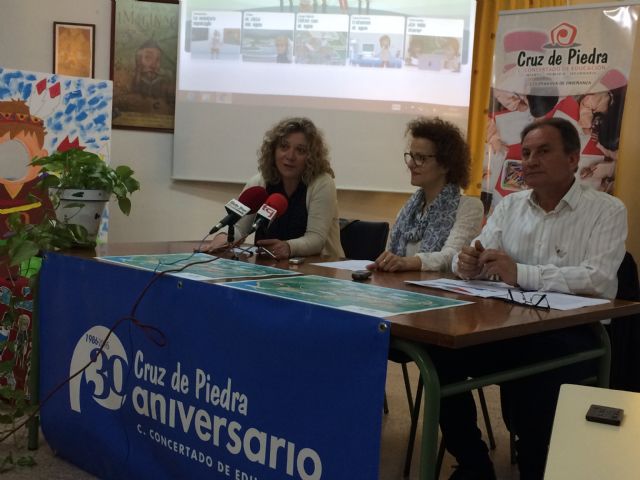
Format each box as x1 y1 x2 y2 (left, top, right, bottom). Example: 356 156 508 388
53 22 96 78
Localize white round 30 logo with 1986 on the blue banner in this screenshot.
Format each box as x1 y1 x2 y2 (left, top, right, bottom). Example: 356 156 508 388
69 325 129 412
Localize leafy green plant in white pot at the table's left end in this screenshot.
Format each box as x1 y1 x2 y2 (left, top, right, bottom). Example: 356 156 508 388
31 147 140 239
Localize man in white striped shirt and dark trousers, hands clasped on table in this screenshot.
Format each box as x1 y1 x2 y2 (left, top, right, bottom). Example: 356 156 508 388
438 118 627 480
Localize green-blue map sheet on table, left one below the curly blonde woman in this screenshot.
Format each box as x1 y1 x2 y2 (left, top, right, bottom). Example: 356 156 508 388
96 253 299 280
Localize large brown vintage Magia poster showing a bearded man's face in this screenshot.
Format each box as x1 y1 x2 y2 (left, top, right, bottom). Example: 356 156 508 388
111 0 179 132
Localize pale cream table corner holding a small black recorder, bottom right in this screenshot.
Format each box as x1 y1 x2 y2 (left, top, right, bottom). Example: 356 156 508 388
545 385 640 480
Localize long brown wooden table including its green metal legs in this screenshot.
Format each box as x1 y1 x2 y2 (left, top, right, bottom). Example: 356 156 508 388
58 242 640 479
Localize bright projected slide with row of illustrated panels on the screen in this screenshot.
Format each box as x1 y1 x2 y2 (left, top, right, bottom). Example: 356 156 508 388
179 0 470 111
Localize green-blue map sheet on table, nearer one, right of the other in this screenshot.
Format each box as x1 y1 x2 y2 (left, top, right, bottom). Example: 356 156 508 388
224 275 472 317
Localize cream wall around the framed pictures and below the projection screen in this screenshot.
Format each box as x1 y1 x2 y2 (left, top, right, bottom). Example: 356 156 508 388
0 0 408 242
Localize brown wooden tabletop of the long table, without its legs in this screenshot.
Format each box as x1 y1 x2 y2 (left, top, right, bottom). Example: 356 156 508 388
95 241 640 348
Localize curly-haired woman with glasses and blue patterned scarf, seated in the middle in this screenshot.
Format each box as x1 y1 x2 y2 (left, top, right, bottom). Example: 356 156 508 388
367 118 483 272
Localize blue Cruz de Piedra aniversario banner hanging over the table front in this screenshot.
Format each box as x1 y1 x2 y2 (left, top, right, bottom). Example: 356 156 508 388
38 254 389 480
